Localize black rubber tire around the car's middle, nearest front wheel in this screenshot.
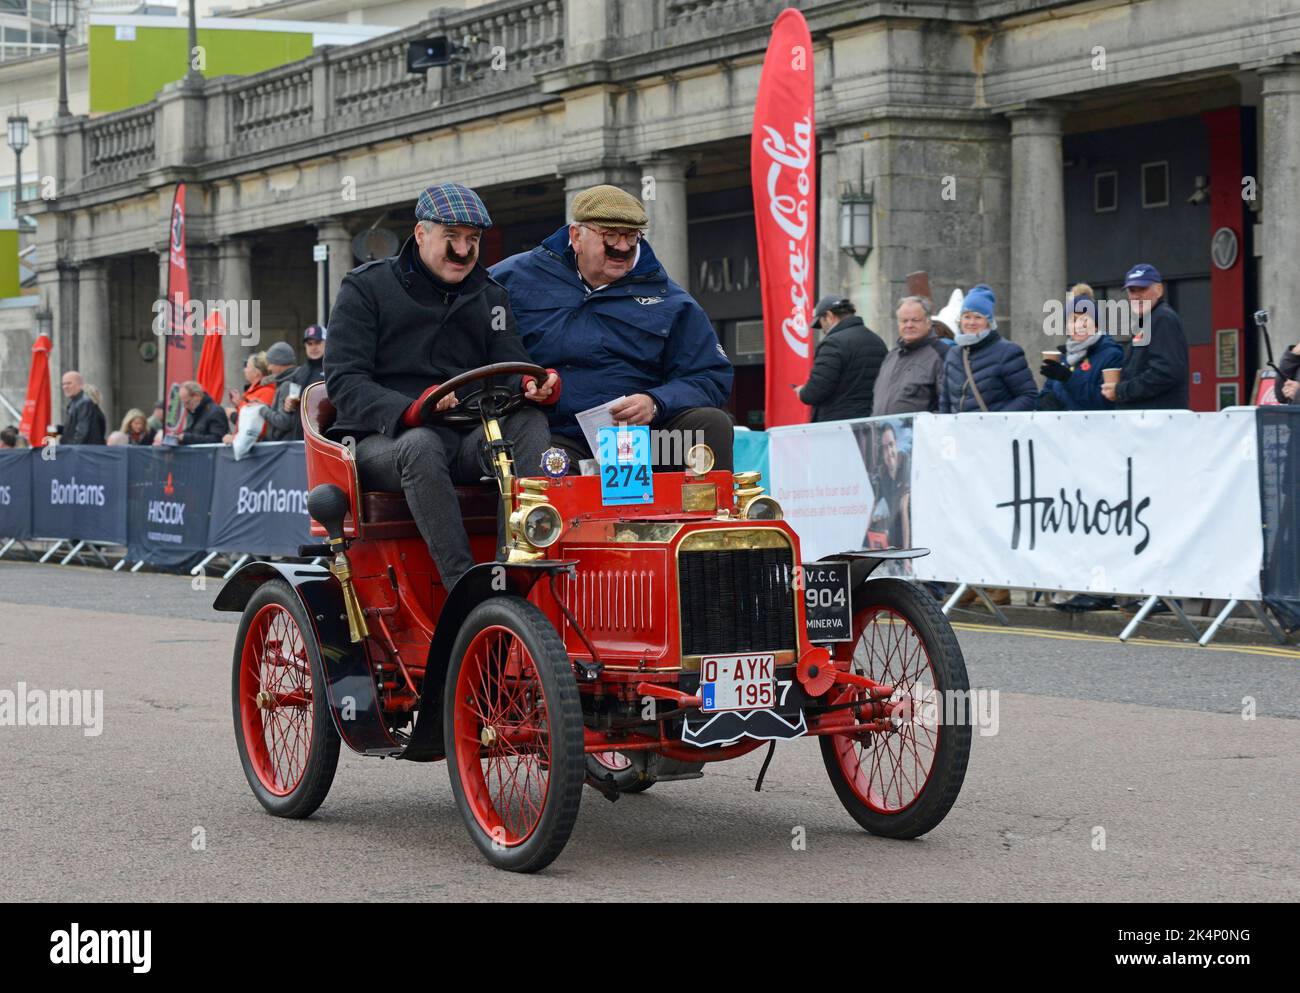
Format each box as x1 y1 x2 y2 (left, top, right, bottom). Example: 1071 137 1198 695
442 597 586 872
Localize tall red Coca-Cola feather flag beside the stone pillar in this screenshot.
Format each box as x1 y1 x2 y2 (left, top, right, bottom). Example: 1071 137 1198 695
750 9 816 428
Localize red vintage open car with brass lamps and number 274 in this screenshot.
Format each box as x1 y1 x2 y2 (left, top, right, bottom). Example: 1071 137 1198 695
215 364 971 872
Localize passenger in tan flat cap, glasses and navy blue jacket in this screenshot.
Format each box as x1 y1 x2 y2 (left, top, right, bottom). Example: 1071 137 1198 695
491 186 732 469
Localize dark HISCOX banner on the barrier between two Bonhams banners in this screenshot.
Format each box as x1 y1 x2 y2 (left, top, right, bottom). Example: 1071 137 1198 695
125 445 215 571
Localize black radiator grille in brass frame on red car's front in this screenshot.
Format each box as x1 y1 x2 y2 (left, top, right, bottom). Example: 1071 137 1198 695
677 548 794 655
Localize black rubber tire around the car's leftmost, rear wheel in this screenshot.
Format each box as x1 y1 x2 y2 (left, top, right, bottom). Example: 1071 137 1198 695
230 580 339 819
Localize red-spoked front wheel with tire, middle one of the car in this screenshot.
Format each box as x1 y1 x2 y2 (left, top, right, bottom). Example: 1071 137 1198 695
443 597 584 872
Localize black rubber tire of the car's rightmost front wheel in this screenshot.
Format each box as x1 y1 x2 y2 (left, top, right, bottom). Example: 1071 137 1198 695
820 578 971 838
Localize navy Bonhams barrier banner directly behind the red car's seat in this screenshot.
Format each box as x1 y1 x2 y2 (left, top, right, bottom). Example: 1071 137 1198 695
208 442 312 555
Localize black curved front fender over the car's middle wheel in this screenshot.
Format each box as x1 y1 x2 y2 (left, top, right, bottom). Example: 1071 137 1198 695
402 559 577 762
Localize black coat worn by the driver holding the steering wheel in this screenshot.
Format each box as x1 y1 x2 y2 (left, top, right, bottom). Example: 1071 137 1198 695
325 238 532 437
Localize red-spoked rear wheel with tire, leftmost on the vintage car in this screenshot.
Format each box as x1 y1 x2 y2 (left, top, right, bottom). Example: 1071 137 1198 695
230 580 339 818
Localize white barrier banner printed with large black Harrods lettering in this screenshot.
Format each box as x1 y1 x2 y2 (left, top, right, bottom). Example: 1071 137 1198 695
904 409 1262 599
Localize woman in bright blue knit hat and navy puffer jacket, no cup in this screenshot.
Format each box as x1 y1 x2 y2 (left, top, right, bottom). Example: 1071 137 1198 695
939 283 1039 413
